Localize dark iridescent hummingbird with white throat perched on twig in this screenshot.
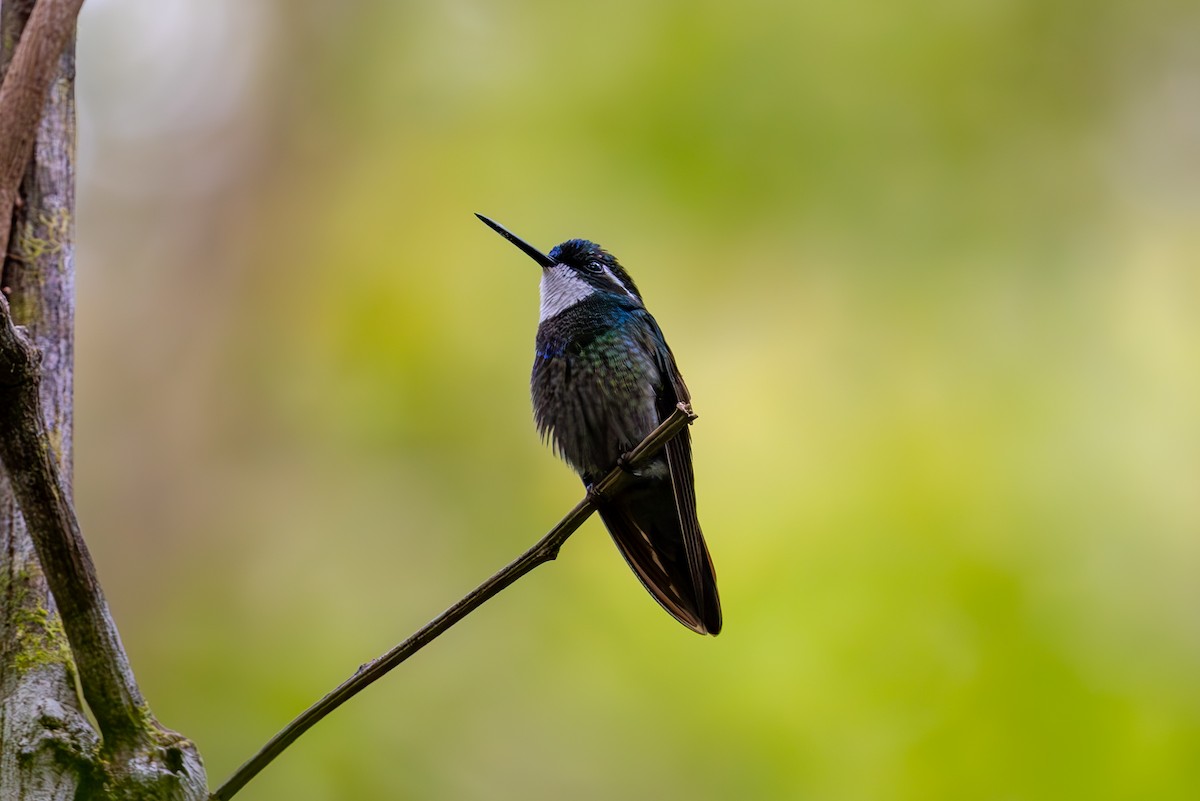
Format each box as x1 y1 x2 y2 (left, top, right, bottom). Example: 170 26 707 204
475 215 721 634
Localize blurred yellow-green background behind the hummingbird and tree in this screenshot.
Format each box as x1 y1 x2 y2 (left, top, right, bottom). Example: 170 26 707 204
76 0 1200 801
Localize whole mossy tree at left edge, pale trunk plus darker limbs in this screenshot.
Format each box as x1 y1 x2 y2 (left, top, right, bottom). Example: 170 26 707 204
0 0 206 801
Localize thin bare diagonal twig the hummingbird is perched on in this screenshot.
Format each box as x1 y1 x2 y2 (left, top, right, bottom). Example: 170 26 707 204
209 403 696 801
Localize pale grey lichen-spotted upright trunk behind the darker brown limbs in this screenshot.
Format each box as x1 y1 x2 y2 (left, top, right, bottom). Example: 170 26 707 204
0 0 98 801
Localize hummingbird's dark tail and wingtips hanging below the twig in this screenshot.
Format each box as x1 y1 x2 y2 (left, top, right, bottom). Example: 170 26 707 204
600 480 721 634
